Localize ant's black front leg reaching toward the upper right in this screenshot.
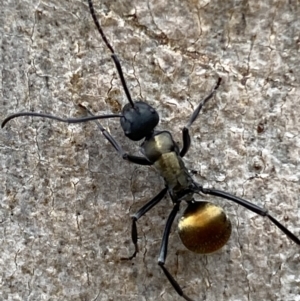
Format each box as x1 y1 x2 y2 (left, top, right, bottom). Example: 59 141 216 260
180 77 222 157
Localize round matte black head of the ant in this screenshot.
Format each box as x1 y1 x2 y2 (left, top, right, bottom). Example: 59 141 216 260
120 101 159 141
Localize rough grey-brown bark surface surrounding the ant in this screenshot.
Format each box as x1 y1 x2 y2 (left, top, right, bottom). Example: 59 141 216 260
0 0 300 301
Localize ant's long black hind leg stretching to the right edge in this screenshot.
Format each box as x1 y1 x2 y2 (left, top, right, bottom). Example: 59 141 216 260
198 186 300 245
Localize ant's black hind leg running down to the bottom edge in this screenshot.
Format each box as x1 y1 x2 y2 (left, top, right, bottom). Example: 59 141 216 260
158 202 193 301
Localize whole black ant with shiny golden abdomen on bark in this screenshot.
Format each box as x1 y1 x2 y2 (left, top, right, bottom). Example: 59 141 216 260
2 0 300 301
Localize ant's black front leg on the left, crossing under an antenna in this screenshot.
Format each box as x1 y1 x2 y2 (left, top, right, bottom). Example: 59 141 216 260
79 105 153 165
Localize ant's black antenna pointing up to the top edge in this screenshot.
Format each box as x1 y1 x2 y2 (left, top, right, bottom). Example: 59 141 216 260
88 0 135 108
